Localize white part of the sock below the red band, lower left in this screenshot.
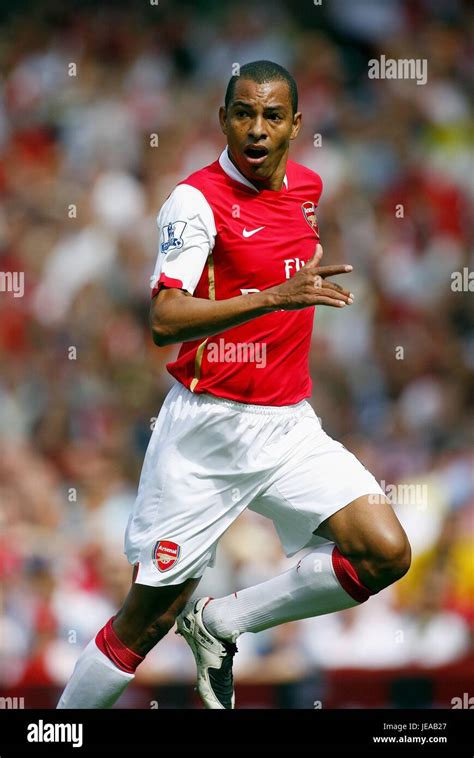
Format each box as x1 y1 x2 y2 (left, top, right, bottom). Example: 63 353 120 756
56 640 135 709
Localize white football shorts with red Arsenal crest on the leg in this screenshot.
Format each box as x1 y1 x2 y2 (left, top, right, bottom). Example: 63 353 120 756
125 382 384 587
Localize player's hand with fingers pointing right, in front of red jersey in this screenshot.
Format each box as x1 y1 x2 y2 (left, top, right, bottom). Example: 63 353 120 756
274 243 354 311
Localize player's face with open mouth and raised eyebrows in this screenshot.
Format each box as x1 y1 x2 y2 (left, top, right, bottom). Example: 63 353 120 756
219 79 301 189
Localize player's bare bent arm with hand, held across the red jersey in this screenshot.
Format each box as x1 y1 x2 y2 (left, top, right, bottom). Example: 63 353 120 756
150 245 352 346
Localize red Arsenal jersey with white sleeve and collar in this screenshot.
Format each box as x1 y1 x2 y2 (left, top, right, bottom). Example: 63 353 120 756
154 151 322 406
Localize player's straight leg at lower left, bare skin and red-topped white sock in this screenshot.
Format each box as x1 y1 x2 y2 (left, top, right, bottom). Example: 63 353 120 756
57 579 199 708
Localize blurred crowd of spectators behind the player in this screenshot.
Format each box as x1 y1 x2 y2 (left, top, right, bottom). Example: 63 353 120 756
0 0 474 708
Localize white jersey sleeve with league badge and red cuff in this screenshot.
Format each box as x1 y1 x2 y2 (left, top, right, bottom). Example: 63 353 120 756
151 184 216 295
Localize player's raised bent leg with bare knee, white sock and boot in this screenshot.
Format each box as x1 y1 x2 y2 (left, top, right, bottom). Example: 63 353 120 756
178 495 411 708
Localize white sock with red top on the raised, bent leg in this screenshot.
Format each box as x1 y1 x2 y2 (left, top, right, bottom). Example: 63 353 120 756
203 543 373 642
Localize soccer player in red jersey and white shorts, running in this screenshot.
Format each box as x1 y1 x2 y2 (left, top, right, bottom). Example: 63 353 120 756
58 61 410 709
